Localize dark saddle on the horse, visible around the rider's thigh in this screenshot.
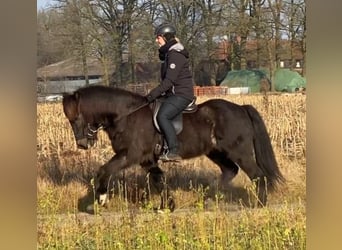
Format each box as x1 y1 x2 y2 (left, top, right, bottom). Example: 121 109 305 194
152 96 197 135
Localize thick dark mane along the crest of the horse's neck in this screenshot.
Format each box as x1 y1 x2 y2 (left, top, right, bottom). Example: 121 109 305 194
76 85 145 117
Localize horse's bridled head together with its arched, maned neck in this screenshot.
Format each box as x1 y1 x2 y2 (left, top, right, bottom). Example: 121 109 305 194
63 85 147 149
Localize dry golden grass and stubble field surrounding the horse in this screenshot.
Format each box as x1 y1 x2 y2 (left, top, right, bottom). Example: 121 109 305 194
37 94 306 250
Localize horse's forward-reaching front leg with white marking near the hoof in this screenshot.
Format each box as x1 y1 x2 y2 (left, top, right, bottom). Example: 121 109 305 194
95 154 129 206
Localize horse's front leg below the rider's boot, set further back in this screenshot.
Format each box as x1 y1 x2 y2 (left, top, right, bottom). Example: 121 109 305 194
142 163 175 211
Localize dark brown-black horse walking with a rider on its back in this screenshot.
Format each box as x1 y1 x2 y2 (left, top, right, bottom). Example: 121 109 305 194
63 85 284 210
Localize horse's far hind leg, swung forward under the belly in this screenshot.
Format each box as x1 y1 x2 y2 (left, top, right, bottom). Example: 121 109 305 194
207 150 239 187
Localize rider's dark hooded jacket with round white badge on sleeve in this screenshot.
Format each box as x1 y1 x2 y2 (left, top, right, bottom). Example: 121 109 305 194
148 42 194 100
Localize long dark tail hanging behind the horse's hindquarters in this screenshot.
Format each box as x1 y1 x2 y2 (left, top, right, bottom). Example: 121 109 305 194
243 105 285 191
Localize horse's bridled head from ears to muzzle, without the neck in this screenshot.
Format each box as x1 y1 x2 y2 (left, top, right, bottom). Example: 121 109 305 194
63 92 100 149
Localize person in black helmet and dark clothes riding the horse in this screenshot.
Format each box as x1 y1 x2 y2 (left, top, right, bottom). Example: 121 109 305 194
146 23 194 161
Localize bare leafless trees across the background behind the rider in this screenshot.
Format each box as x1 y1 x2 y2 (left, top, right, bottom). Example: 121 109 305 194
37 0 306 89
